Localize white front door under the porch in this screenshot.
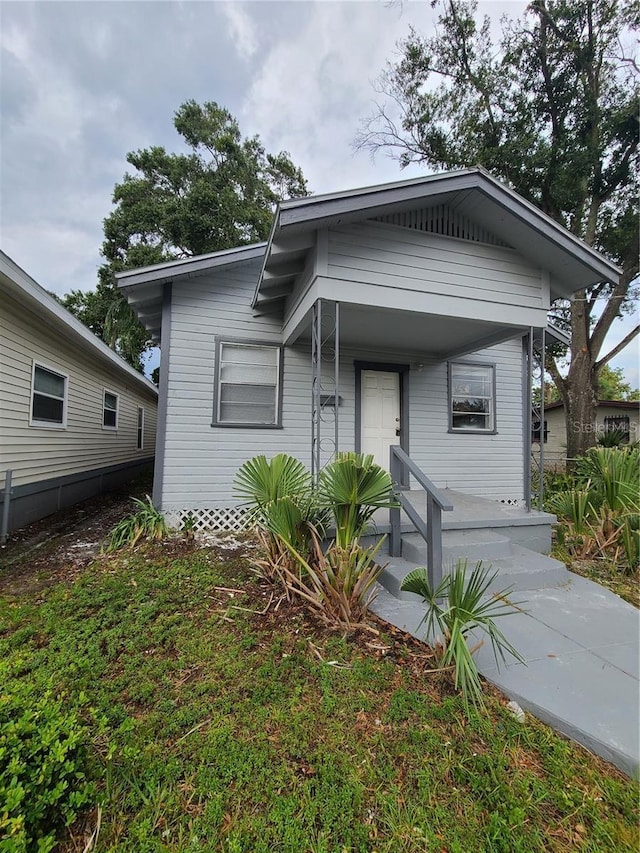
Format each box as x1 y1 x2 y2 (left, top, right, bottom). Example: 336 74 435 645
360 370 400 471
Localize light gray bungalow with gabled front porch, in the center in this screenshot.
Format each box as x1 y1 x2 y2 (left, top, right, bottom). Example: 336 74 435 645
118 168 619 526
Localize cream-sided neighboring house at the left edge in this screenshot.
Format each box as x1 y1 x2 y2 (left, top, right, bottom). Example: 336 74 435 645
0 252 158 535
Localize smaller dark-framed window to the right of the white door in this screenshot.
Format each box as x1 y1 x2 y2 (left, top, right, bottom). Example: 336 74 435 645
449 362 495 432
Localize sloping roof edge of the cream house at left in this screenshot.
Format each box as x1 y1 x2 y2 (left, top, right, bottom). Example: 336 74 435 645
0 251 158 397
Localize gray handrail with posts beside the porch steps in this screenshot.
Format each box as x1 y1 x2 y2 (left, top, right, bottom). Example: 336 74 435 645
389 445 453 589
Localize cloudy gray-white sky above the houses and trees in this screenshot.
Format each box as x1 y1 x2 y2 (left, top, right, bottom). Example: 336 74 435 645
0 0 638 385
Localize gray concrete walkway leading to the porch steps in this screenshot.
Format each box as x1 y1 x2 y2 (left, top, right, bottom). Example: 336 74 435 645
372 573 640 777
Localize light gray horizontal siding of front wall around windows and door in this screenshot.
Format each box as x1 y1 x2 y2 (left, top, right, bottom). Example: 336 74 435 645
162 250 523 510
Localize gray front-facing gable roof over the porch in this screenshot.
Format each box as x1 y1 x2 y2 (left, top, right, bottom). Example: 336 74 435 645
253 167 620 307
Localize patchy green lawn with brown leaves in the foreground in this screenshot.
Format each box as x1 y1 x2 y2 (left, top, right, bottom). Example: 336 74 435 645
0 541 638 853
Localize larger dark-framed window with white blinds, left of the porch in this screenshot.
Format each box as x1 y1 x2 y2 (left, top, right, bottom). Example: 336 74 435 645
213 341 282 427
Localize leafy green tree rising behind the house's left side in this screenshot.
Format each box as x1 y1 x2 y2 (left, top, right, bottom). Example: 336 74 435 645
62 101 307 370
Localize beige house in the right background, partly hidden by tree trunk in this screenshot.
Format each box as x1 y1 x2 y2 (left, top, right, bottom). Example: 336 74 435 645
532 400 640 469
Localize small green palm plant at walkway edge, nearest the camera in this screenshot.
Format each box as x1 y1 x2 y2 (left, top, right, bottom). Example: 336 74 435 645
402 560 524 713
